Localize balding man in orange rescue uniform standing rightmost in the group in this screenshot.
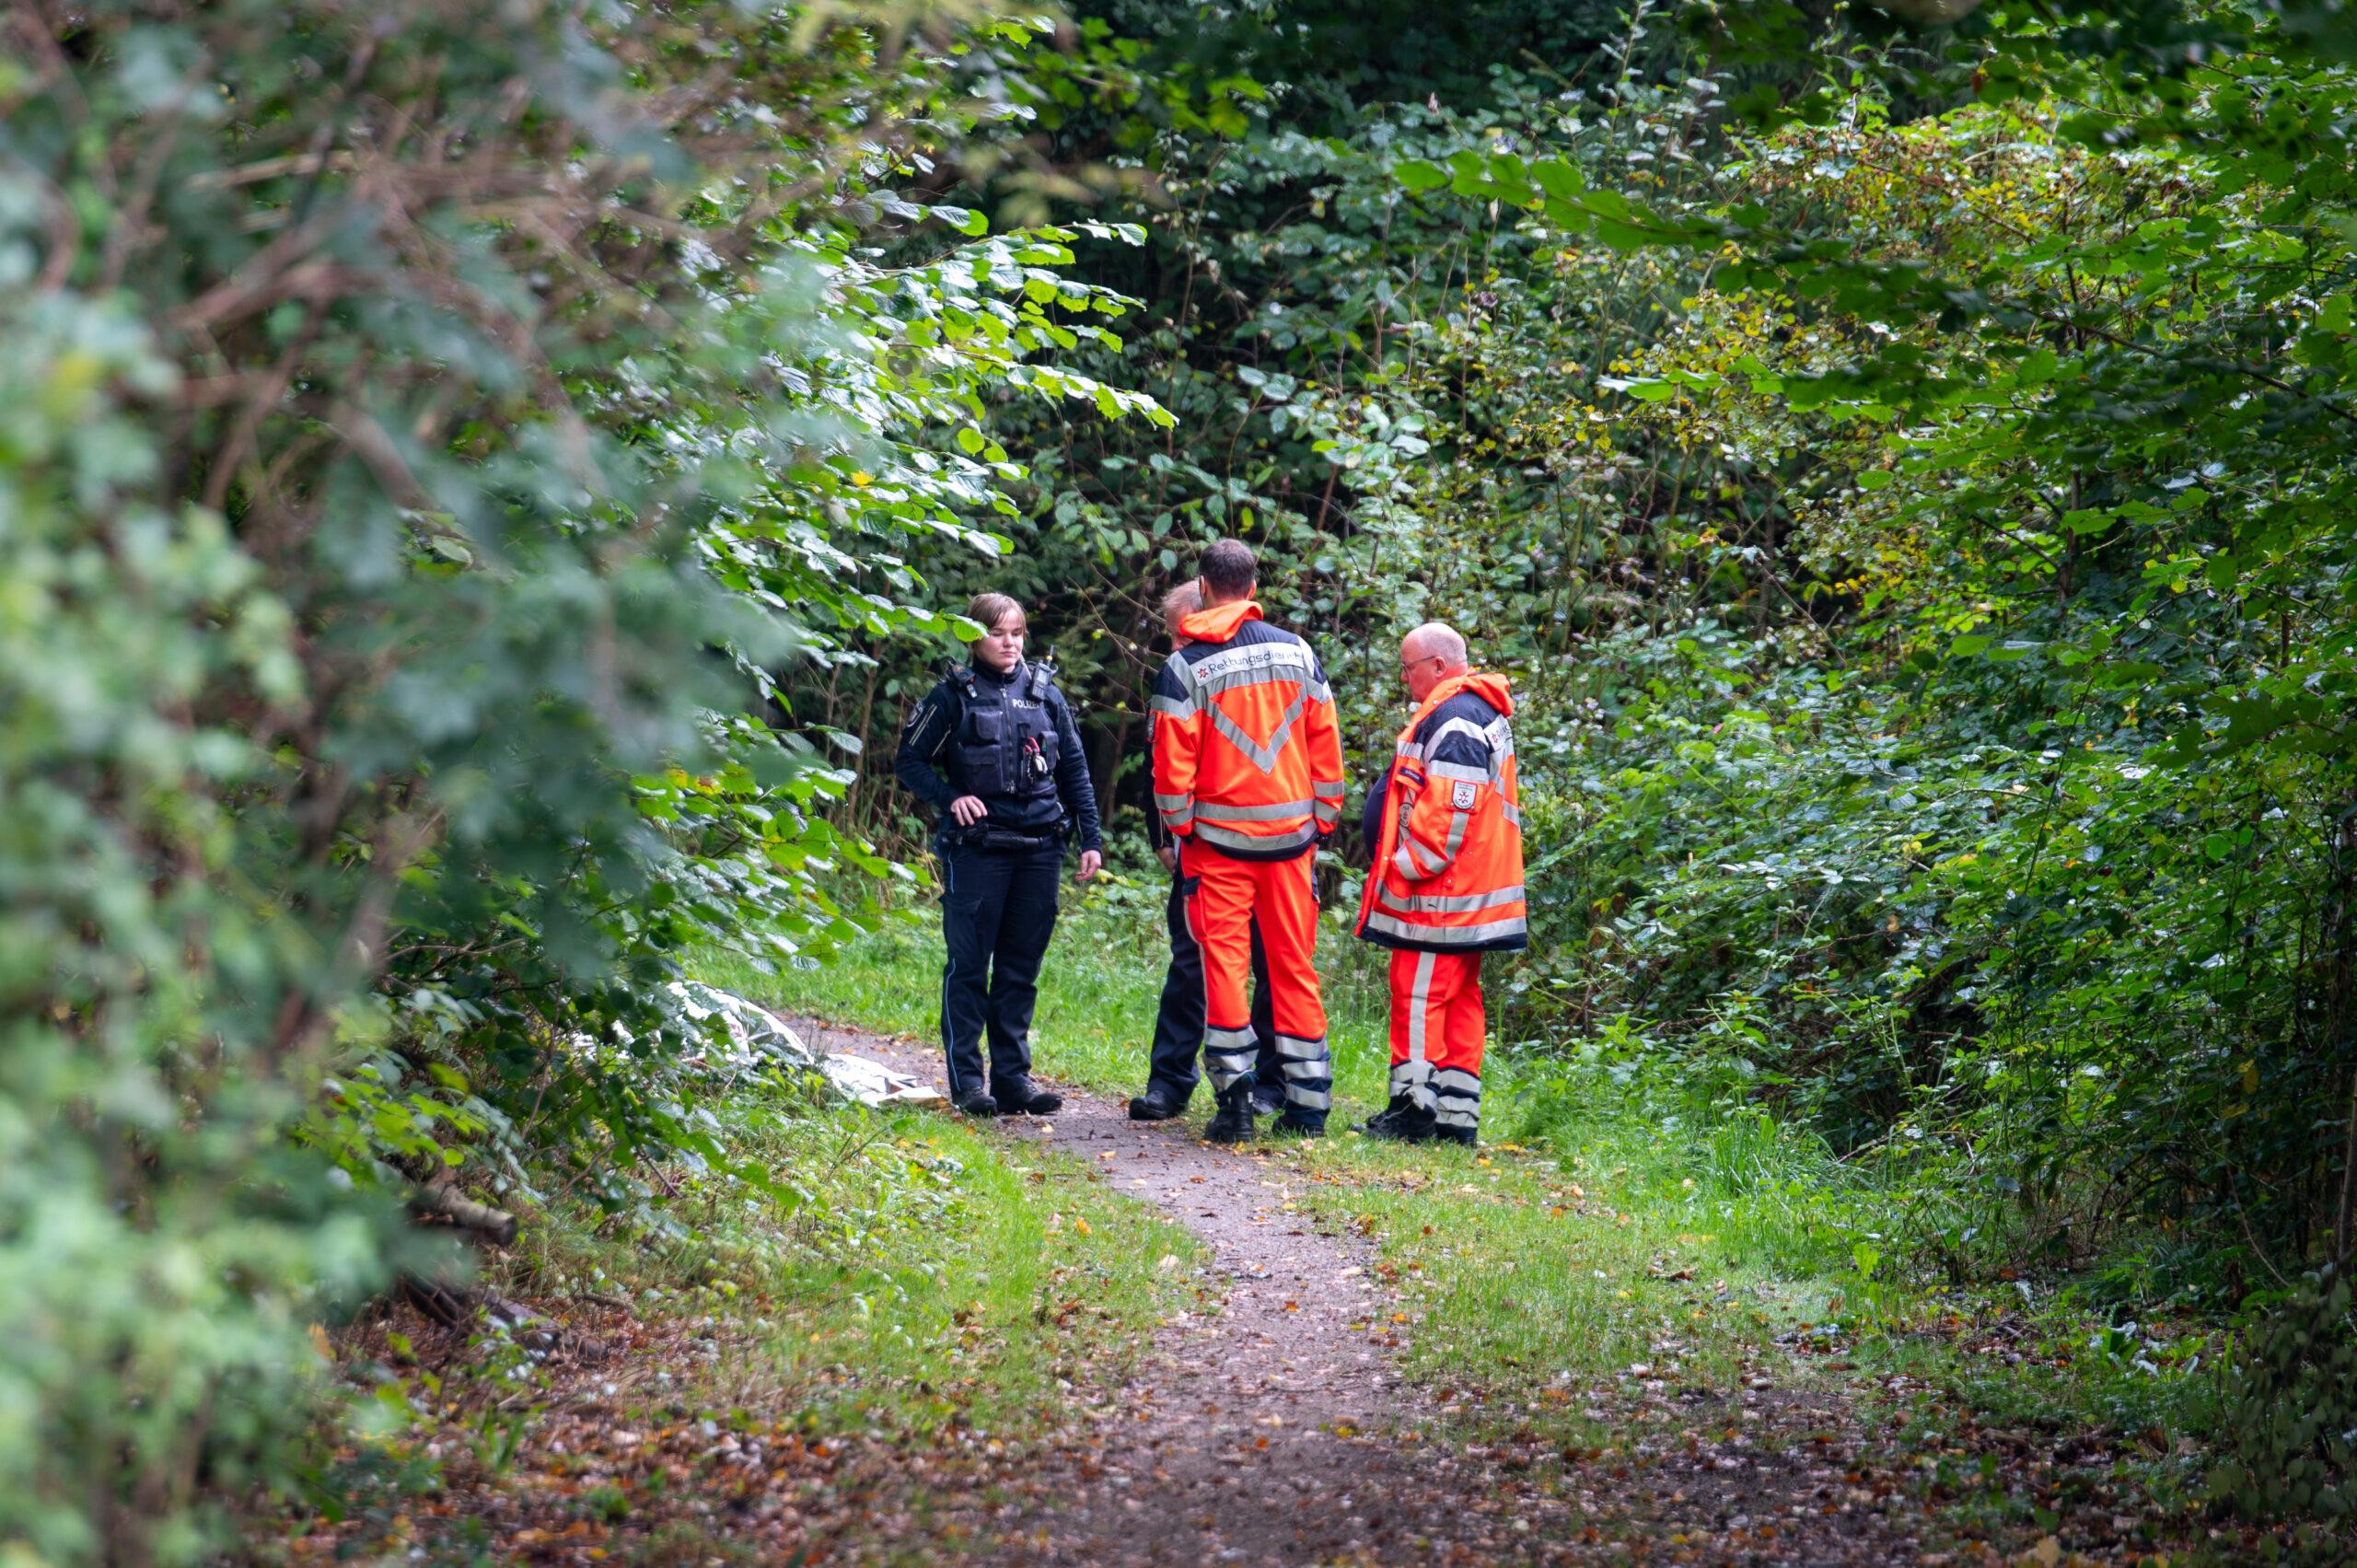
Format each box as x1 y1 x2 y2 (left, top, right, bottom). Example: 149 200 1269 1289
1358 621 1529 1144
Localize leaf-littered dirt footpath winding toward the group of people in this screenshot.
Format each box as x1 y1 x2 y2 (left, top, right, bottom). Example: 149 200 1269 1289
795 1018 1923 1568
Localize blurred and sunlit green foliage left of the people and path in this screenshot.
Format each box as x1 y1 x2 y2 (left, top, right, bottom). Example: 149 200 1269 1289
0 3 1153 1561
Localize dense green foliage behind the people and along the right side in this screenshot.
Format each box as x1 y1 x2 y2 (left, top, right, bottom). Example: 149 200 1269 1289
796 5 2357 1495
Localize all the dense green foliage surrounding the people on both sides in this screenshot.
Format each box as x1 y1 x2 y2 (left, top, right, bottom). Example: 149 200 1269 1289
14 0 2357 1561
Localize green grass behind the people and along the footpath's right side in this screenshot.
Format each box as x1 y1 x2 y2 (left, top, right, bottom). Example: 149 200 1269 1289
700 875 2209 1481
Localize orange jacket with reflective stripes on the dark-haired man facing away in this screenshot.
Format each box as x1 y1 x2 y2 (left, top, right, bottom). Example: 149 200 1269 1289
1153 598 1341 861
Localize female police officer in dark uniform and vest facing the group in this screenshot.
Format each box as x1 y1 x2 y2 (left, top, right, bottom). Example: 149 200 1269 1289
893 594 1103 1115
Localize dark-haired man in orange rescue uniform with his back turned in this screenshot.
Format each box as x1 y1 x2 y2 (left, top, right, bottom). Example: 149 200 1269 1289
1153 540 1341 1144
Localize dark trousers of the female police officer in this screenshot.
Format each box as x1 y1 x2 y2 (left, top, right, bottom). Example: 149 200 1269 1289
940 842 1063 1098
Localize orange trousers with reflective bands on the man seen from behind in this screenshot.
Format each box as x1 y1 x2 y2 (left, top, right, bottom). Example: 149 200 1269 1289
1178 840 1334 1115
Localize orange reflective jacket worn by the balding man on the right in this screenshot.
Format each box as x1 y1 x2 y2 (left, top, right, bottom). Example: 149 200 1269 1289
1358 674 1529 953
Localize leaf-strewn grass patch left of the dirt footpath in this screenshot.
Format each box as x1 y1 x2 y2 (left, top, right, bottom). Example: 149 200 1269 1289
509 1089 1207 1434
